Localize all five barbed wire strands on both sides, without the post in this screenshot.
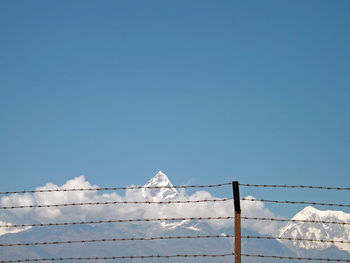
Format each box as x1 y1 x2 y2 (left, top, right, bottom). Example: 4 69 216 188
0 182 350 263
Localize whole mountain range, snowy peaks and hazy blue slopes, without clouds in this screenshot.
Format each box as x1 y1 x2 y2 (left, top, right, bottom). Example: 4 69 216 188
0 172 350 263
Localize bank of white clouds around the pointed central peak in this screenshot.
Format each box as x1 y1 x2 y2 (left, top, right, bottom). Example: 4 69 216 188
0 176 276 235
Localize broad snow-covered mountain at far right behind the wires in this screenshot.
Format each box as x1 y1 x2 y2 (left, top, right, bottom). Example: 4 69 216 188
279 206 350 253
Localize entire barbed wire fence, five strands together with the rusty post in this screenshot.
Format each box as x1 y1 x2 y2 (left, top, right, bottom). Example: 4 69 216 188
0 181 350 263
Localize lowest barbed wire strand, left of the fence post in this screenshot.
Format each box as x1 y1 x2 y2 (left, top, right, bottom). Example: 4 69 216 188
0 253 234 263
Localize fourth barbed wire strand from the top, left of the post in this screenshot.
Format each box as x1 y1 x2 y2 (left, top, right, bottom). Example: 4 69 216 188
0 235 233 247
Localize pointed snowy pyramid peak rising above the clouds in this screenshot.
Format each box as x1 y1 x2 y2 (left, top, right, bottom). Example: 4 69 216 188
142 171 178 201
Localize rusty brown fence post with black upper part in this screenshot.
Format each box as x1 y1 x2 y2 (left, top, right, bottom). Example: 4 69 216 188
232 181 241 263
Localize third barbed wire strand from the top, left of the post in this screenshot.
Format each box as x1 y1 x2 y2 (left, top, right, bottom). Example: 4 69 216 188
0 216 234 227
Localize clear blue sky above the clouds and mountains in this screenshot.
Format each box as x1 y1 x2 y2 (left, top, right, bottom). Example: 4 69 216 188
0 0 350 217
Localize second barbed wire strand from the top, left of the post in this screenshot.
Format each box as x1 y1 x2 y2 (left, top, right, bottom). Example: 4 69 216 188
0 197 233 210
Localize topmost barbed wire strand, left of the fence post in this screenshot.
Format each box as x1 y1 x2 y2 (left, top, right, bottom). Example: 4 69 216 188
0 182 232 195
